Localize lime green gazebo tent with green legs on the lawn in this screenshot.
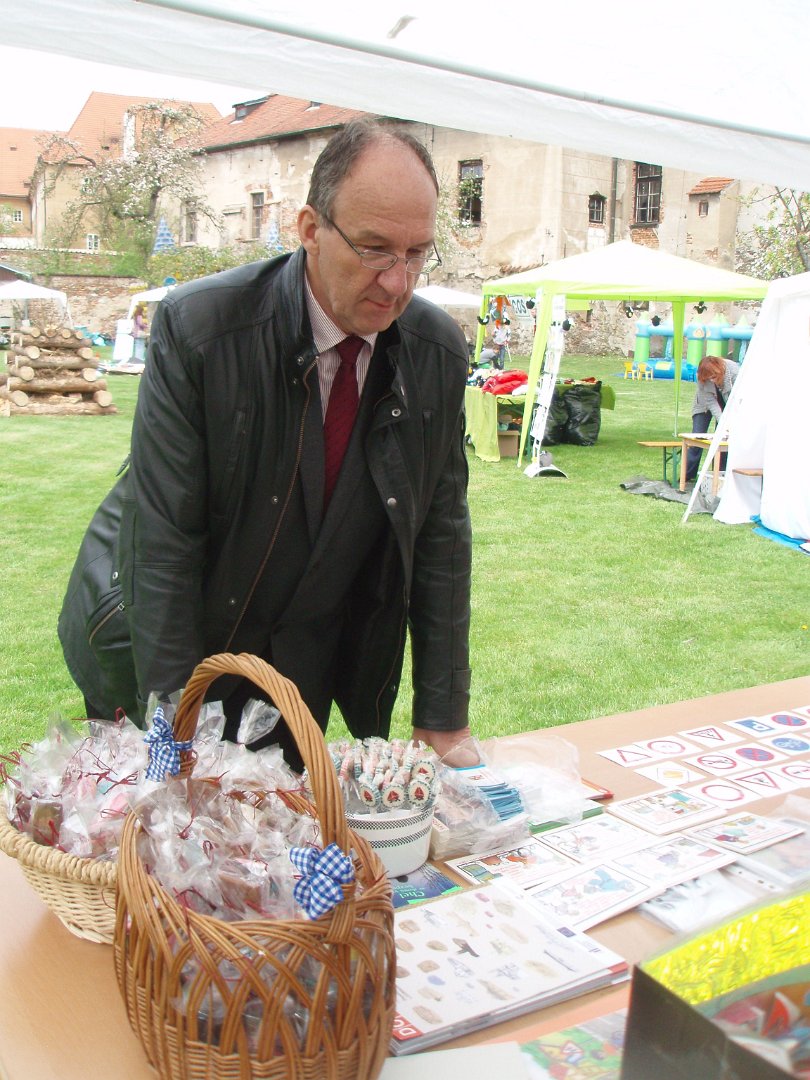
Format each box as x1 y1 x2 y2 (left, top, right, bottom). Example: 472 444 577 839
475 240 769 467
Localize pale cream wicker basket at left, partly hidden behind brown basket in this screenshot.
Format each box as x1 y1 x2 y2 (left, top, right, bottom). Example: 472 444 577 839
0 777 118 945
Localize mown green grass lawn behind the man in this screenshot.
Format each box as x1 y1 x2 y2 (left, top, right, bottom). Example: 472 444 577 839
0 356 810 750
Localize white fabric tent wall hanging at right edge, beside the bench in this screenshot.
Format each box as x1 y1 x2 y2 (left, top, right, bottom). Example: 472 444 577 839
706 273 810 540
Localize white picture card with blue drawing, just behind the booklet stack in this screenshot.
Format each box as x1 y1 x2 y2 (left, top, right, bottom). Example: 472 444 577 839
526 863 657 930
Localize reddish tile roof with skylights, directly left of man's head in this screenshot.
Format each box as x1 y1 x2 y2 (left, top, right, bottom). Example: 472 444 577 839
191 94 368 150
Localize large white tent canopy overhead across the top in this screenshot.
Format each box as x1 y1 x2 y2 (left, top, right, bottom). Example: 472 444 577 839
3 0 810 190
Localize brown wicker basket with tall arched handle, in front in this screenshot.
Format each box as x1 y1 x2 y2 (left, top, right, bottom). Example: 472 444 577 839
114 653 395 1080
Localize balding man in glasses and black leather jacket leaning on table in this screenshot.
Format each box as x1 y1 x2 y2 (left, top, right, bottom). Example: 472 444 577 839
59 121 471 768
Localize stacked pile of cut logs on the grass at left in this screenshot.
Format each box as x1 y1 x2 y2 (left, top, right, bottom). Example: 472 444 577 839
0 326 118 416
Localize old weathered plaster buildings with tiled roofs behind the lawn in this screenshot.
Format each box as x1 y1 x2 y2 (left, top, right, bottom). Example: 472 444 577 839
0 94 762 343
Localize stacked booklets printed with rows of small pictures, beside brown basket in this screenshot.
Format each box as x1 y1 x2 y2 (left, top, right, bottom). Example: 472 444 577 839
391 883 629 1055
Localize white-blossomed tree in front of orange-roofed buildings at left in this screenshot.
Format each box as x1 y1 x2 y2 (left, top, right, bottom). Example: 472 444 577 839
40 102 219 267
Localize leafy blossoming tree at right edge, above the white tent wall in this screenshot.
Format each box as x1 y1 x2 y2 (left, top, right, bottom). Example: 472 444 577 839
735 188 810 280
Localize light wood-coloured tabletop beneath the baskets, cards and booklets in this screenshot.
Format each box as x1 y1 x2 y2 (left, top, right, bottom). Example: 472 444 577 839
0 677 810 1080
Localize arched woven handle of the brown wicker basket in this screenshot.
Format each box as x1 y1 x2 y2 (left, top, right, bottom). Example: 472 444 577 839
174 652 352 853
